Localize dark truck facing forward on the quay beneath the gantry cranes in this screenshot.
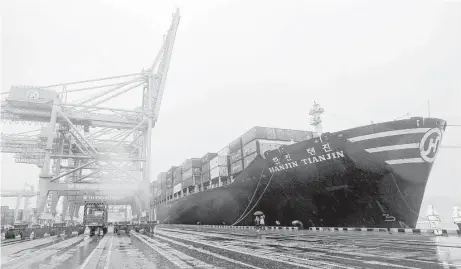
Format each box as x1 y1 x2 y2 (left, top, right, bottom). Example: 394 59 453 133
83 202 108 236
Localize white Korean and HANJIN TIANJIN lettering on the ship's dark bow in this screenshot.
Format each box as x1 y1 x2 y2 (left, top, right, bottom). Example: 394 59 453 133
266 138 345 173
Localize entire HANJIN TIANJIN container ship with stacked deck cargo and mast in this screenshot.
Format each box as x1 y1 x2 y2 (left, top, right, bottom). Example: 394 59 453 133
151 104 446 228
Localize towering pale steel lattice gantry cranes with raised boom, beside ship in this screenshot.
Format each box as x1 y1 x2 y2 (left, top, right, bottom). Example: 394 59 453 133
1 10 180 221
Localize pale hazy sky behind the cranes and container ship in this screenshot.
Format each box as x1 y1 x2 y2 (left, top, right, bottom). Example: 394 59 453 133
1 0 461 222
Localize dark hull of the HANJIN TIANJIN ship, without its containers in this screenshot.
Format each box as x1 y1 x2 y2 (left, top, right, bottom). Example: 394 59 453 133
155 118 445 228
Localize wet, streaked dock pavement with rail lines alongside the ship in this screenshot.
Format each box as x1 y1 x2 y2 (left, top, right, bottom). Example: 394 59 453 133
1 226 461 269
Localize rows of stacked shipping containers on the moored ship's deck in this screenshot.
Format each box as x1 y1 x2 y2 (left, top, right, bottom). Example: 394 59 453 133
151 126 313 204
